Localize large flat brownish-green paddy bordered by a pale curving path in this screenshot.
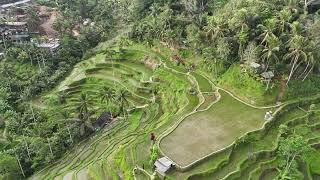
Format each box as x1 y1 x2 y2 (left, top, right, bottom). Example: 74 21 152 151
160 92 268 166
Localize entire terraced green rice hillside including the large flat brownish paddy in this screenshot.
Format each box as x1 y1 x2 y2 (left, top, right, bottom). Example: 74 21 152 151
31 45 320 180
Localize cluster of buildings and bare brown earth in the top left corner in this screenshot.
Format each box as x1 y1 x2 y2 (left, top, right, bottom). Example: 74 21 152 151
0 0 60 55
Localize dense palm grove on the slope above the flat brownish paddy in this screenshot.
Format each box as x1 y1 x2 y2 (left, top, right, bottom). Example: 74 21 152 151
132 0 320 84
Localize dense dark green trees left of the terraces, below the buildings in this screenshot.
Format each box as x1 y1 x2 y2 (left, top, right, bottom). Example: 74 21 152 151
0 34 97 179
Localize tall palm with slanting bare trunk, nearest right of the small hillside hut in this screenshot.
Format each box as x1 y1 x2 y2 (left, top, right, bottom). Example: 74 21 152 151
284 35 308 85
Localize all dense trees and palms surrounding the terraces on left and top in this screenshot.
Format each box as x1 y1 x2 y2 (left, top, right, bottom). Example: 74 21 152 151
0 0 320 179
